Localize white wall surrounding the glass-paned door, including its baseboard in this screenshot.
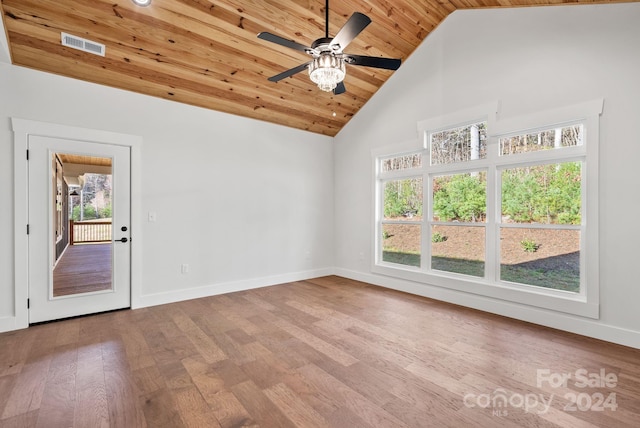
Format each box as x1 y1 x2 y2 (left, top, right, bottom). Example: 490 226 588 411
0 62 333 331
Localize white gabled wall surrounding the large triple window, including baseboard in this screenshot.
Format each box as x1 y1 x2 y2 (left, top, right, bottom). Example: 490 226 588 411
334 3 640 347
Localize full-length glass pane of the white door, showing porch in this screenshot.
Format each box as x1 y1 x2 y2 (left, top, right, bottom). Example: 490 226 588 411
51 153 113 297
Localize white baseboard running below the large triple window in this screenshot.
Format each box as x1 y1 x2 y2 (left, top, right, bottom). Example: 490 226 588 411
334 268 640 349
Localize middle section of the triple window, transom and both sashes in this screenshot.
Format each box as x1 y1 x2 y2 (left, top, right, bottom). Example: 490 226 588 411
425 121 487 278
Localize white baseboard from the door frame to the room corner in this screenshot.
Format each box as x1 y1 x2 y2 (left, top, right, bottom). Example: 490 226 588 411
131 268 334 309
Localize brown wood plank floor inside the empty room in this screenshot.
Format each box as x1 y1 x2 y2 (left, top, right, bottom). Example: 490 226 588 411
0 276 640 428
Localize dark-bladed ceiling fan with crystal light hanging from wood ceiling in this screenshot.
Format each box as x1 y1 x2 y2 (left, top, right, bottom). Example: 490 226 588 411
258 0 401 95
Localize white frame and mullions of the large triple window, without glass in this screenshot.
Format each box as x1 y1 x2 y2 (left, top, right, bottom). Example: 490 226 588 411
371 99 604 319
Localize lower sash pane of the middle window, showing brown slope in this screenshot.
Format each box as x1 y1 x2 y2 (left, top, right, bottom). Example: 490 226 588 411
431 225 485 277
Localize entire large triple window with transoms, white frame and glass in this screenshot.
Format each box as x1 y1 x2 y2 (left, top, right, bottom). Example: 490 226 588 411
373 100 602 318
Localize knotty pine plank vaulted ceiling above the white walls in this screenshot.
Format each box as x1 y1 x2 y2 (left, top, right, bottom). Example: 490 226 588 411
1 0 636 136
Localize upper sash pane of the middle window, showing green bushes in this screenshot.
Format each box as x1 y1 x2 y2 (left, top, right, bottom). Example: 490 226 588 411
432 171 487 223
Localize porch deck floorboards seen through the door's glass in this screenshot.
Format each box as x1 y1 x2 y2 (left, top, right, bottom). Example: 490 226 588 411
53 243 111 297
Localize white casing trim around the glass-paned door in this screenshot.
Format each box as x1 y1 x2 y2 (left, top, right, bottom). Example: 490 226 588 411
11 118 142 330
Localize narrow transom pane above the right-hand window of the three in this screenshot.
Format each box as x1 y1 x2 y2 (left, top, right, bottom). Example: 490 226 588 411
500 124 583 155
